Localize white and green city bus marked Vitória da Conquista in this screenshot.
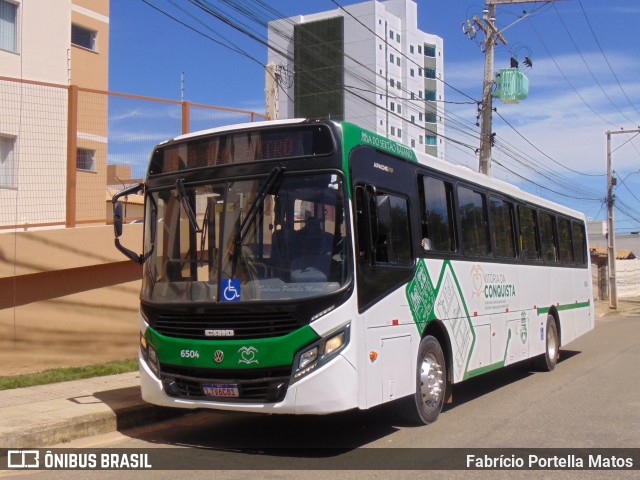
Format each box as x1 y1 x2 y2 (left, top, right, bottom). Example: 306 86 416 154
113 120 594 423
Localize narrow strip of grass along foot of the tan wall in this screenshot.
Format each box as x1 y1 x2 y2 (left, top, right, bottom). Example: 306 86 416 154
0 358 138 390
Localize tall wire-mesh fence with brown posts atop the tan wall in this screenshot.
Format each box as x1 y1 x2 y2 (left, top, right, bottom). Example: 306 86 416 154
0 77 265 232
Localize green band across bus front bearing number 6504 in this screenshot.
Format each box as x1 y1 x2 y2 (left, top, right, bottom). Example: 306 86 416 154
145 325 320 370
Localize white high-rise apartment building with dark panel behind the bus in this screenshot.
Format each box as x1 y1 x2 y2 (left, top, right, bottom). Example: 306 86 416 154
269 0 445 158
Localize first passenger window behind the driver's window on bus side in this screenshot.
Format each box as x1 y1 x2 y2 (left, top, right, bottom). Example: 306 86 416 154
418 175 457 252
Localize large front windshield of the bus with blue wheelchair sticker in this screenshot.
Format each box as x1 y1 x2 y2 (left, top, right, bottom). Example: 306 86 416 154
142 169 351 303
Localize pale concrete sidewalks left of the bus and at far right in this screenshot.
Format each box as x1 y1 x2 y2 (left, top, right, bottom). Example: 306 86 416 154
0 298 640 448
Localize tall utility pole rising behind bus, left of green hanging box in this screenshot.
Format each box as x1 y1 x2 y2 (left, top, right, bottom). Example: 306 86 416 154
465 0 558 175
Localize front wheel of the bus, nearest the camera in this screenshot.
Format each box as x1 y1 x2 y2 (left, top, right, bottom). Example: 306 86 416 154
404 335 447 425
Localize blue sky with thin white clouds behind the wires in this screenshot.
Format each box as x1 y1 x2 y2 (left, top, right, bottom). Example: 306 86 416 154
109 0 640 232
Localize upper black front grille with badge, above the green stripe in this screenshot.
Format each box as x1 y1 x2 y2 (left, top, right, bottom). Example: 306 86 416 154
152 311 301 340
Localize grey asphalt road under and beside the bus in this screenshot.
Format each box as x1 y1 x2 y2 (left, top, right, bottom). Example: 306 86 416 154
6 316 640 480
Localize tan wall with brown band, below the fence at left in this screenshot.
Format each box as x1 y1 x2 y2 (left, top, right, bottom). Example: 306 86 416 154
0 224 142 376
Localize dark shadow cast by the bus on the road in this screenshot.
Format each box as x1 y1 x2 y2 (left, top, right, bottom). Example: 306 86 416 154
122 350 581 459
